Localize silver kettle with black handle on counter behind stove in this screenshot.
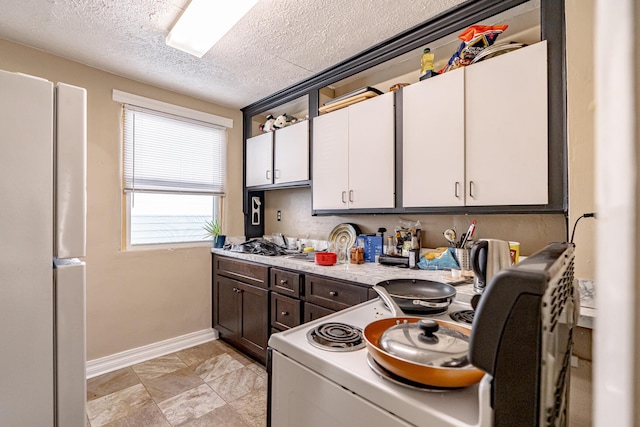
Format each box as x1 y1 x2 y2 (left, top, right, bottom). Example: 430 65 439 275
471 239 511 292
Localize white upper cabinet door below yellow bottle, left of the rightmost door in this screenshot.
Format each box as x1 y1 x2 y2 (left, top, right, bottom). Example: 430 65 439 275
402 68 465 207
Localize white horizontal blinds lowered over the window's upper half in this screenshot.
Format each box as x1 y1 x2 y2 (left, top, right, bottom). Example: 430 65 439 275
124 105 227 195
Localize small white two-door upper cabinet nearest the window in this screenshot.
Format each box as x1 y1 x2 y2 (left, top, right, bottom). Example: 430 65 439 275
246 120 309 187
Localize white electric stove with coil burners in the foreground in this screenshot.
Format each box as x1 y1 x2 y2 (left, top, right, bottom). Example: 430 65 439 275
269 300 491 427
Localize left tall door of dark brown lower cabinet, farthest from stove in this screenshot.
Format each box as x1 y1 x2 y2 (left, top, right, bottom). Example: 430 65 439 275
213 275 240 340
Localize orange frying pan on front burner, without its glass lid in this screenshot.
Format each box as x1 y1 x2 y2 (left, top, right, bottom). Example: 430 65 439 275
363 286 484 388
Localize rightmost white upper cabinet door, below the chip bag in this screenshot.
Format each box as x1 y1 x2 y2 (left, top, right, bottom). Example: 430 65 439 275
465 41 548 206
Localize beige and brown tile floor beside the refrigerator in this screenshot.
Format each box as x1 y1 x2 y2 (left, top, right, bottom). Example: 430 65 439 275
87 340 267 427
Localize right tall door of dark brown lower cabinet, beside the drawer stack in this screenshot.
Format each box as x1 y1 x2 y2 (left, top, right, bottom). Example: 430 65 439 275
238 283 269 363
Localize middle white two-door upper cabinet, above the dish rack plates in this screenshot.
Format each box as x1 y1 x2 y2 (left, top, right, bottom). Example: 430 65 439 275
313 93 395 210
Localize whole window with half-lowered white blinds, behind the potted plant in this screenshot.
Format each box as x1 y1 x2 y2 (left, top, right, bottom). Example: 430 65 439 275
121 98 227 247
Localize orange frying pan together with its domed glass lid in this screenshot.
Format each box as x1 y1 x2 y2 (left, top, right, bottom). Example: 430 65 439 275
363 285 484 388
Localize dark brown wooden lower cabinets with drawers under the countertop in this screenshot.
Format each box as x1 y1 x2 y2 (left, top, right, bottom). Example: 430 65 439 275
212 255 376 363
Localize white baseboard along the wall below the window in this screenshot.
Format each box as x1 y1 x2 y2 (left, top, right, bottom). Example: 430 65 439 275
87 328 218 379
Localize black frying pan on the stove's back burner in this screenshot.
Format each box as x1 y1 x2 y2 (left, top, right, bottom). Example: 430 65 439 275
377 279 456 314
